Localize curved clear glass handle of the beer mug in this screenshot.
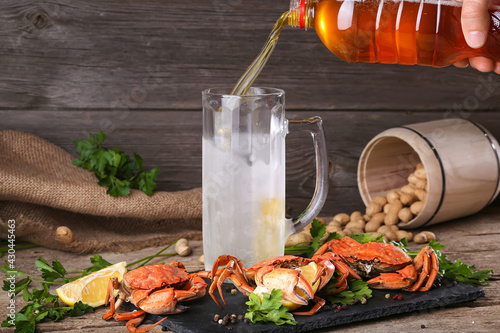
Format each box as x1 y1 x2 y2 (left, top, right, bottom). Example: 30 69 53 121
288 117 328 233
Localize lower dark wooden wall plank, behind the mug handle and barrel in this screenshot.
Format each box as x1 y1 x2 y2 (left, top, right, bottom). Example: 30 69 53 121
0 111 500 215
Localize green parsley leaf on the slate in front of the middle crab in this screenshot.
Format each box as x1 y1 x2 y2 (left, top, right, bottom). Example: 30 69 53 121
245 289 297 325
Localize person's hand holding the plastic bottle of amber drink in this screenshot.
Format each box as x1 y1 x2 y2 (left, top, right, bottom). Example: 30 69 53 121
454 0 500 74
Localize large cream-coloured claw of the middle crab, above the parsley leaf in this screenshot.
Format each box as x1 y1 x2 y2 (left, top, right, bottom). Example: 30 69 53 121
259 266 314 305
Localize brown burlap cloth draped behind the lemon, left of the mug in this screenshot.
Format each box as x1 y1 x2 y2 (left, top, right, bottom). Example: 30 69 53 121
0 131 202 253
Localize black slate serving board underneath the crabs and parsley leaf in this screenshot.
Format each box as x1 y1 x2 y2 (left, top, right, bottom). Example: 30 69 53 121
122 280 485 333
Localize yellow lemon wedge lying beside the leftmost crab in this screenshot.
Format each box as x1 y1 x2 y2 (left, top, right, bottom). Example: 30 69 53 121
56 261 127 308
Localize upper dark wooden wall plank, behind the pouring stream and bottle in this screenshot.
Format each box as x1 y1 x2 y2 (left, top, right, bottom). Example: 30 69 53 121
0 0 500 111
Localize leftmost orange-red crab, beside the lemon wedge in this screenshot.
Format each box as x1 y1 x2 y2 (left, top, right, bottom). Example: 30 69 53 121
103 262 207 333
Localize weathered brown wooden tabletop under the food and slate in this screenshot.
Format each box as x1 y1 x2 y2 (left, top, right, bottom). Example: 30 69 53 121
0 207 500 333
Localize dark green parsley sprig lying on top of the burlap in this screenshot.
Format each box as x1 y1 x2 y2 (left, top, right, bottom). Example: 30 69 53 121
72 131 158 197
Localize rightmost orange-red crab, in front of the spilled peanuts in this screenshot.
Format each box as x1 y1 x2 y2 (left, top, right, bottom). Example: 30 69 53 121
315 237 439 291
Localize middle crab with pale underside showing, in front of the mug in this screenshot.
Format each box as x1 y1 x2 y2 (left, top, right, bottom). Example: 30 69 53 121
209 252 360 315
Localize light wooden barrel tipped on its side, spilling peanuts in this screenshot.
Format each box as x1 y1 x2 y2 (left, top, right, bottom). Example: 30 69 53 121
358 119 500 228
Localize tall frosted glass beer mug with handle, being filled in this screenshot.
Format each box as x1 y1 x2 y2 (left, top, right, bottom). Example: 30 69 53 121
202 87 328 270
